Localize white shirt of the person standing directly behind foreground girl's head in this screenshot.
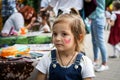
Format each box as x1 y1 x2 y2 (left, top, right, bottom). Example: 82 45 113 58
50 0 83 13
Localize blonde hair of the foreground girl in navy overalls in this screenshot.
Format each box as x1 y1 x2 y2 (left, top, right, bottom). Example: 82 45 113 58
52 8 86 51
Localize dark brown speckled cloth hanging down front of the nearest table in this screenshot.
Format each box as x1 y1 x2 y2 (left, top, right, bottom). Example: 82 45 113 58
0 57 37 80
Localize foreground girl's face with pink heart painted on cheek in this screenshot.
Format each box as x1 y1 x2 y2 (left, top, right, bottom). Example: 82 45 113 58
52 23 75 51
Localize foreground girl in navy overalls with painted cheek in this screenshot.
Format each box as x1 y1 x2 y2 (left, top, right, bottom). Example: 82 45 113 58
36 9 95 80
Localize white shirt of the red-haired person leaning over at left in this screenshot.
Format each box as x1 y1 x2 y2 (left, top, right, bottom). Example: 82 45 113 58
1 12 24 34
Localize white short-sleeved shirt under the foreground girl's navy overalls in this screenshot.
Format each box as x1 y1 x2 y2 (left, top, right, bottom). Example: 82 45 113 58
36 53 95 78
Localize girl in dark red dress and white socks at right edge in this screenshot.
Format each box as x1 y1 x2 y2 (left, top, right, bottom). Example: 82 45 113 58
108 1 120 58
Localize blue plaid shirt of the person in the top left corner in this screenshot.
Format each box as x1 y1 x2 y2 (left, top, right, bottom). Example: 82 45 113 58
1 0 17 25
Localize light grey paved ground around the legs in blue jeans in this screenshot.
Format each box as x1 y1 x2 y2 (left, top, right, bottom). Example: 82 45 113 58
85 31 120 80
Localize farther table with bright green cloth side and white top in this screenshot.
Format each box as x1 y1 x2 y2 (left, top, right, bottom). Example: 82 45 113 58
0 32 51 45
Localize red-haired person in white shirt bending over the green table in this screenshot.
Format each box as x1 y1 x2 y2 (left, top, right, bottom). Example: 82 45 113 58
1 5 36 36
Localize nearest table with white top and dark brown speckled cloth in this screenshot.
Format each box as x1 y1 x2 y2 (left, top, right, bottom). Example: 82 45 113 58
0 44 53 80
